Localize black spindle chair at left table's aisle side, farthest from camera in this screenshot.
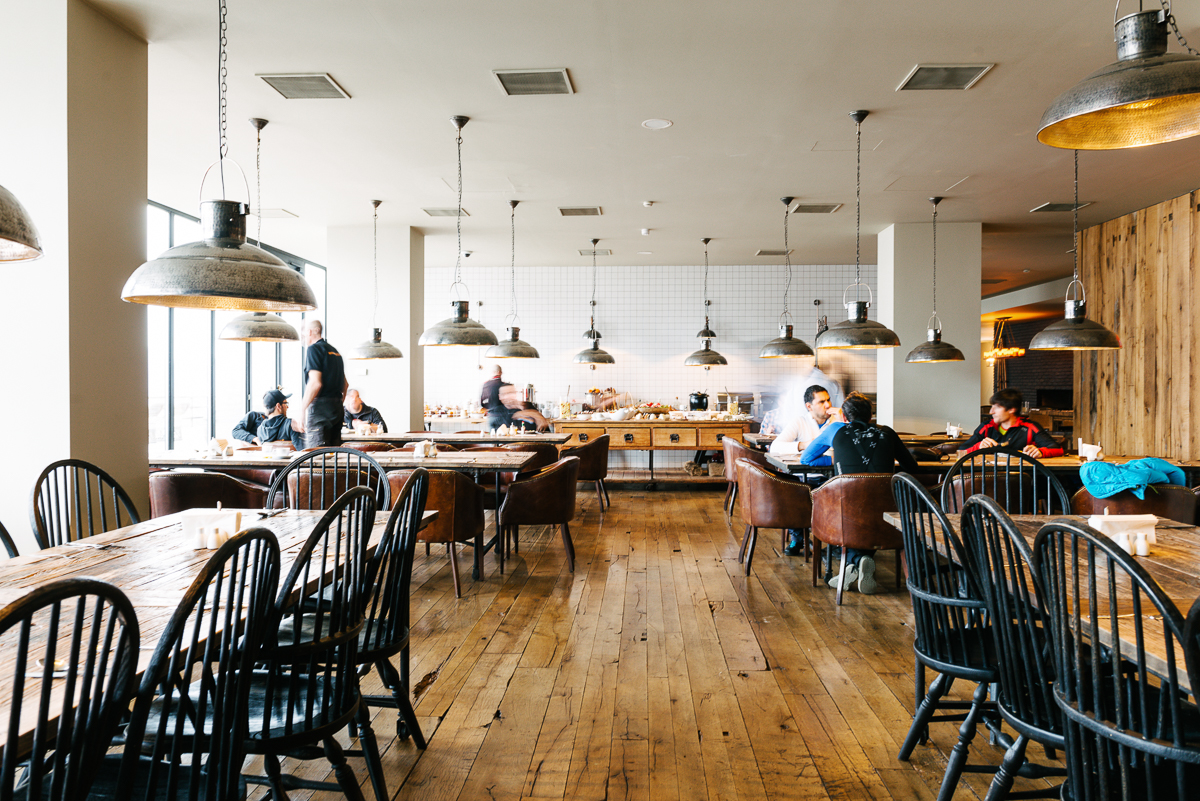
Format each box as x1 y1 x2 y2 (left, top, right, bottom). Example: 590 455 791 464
358 468 430 748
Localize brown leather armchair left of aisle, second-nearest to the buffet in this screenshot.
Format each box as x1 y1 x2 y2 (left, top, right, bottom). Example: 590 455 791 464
497 456 580 572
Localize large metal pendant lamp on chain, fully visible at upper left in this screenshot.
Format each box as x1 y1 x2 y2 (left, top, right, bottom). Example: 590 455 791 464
121 0 317 312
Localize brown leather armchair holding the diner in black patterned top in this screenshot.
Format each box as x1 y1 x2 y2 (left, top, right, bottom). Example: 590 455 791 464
812 472 904 606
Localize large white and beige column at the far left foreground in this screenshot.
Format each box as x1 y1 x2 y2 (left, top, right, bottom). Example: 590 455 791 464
0 0 149 552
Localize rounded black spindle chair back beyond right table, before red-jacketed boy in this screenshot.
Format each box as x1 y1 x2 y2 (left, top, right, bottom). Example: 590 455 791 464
942 447 1070 514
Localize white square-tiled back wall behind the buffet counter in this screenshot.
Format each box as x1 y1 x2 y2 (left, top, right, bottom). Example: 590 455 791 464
425 264 876 466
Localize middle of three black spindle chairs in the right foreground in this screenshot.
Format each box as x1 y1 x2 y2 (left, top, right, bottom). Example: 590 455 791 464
961 495 1066 801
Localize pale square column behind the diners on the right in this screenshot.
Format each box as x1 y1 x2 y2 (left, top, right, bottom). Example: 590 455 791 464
872 221 983 434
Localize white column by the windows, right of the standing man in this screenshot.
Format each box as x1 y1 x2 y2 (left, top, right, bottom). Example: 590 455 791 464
326 221 425 432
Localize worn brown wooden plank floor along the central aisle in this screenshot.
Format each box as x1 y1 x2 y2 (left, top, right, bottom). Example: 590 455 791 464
247 486 1057 801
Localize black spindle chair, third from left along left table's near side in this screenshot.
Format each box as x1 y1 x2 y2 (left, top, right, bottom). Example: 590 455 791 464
246 487 389 801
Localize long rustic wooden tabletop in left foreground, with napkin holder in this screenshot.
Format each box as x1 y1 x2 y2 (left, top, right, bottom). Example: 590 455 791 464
0 510 438 751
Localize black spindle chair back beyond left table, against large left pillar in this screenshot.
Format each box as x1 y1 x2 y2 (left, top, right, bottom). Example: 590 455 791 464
29 459 142 548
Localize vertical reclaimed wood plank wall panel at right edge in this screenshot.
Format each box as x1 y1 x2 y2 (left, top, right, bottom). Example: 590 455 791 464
1075 193 1200 459
